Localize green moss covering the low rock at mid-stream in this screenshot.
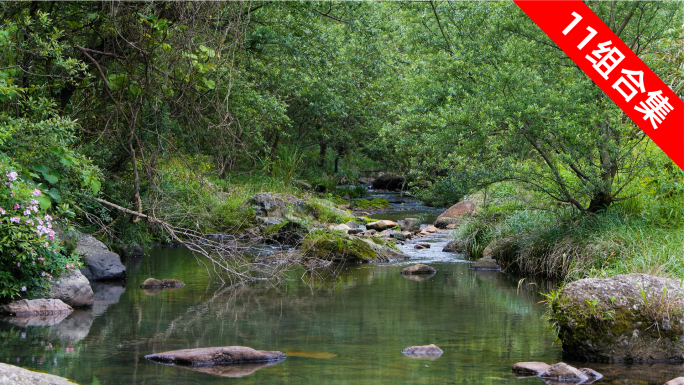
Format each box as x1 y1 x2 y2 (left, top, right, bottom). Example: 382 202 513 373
303 230 377 262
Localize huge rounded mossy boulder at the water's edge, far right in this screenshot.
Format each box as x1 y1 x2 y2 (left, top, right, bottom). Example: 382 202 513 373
551 274 684 363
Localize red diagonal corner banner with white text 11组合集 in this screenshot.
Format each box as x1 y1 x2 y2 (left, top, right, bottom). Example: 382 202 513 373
514 0 684 169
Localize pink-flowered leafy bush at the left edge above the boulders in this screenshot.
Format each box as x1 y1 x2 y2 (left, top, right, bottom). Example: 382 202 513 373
0 160 80 302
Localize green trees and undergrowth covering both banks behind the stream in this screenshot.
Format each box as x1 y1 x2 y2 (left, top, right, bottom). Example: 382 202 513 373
0 2 684 296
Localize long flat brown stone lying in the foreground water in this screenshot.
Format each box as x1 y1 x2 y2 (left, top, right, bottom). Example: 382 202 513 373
145 346 285 367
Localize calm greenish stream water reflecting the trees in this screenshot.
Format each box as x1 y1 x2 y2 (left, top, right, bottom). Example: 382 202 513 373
0 197 684 385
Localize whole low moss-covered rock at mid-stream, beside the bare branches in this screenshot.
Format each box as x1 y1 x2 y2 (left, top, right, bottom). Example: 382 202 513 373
303 230 408 263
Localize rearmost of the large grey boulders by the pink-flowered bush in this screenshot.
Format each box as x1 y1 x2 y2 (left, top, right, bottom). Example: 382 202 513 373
74 234 126 282
